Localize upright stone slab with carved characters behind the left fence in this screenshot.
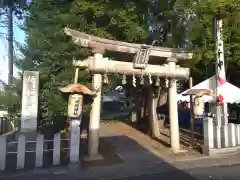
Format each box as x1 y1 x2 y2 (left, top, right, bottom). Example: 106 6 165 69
21 71 39 133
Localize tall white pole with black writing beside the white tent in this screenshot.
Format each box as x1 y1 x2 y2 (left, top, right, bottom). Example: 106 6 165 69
214 16 228 147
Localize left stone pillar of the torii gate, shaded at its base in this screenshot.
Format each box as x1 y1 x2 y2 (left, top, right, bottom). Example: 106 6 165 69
86 49 104 161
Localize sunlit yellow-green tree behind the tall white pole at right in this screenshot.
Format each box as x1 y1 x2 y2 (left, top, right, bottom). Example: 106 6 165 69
174 0 240 80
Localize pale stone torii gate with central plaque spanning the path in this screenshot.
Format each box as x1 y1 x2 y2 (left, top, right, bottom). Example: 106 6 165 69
64 28 193 160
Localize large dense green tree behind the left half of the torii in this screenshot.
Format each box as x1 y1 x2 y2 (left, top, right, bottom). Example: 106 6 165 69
23 0 151 119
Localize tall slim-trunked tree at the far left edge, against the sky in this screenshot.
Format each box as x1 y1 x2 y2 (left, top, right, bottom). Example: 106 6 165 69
0 0 26 115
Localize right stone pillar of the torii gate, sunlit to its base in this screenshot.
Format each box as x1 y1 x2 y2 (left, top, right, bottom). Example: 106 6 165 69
168 59 180 153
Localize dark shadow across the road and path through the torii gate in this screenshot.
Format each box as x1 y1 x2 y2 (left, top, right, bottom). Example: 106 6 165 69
0 130 232 180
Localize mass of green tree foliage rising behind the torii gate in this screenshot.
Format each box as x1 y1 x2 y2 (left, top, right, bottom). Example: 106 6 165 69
19 0 240 121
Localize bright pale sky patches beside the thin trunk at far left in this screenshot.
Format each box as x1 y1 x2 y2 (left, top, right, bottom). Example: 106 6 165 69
0 14 25 82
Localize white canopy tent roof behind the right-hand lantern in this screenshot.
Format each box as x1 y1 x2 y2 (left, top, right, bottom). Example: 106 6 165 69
177 76 240 103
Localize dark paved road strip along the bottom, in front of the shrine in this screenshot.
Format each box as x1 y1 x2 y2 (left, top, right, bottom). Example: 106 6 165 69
0 164 240 180
